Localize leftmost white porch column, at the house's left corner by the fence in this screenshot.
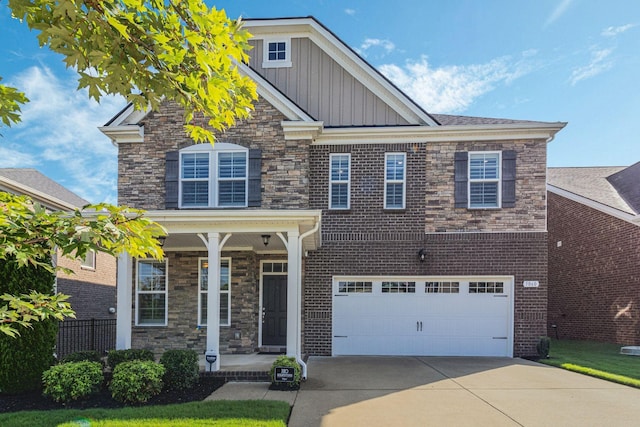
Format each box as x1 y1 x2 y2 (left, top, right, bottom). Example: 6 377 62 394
116 252 133 350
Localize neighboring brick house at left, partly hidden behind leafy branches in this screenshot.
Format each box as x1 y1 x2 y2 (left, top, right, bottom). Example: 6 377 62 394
0 168 116 320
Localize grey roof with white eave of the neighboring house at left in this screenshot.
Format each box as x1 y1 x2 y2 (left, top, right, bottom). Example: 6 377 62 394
0 168 89 210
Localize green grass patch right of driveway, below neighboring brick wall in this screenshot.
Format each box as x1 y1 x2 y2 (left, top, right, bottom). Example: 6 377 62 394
540 339 640 388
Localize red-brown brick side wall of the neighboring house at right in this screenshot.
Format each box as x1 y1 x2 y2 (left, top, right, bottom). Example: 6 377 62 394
549 193 640 345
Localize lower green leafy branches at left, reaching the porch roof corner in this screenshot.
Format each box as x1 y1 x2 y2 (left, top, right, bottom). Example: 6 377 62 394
0 192 166 336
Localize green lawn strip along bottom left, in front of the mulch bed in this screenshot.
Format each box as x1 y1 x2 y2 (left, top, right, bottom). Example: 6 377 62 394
0 400 290 427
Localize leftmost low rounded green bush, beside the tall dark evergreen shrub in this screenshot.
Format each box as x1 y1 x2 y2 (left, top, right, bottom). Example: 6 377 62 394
42 362 104 402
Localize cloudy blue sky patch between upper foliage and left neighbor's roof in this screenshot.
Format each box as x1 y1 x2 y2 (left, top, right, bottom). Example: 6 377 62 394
0 67 125 203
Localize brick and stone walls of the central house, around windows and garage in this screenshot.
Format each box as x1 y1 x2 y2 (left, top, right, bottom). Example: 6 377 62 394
118 100 547 356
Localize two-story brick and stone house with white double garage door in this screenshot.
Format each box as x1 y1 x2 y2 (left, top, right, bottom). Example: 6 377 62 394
101 17 565 369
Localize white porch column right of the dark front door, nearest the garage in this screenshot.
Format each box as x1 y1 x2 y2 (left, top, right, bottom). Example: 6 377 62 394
287 230 302 357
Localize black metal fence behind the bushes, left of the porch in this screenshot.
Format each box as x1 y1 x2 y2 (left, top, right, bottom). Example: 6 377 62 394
56 319 116 359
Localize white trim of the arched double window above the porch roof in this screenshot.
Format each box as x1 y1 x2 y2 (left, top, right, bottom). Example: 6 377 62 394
178 142 249 209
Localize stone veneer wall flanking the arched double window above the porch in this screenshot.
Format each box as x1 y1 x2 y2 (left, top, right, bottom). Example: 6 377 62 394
118 99 310 210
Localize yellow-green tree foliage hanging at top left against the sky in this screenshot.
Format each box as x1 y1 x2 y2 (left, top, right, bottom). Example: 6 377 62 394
0 0 257 142
